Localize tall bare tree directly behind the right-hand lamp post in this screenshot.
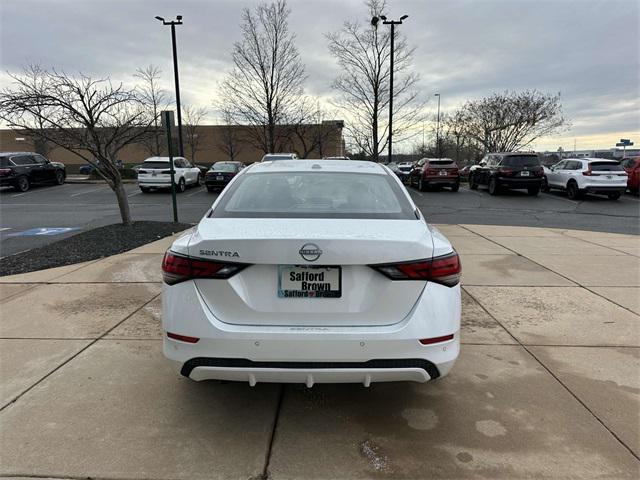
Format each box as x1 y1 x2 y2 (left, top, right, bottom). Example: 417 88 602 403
326 0 424 161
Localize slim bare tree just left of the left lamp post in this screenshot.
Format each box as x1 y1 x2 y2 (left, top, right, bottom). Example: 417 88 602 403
134 65 169 156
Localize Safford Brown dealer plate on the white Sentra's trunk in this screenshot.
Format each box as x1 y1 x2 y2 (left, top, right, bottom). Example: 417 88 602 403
278 265 342 298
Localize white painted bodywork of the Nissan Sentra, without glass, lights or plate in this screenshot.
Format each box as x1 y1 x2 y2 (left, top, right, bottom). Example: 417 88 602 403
163 160 461 386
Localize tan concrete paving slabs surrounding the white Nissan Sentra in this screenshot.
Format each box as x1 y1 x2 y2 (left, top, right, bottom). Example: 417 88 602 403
0 225 640 480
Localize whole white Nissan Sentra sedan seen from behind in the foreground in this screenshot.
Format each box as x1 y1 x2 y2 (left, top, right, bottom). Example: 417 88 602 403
162 160 461 387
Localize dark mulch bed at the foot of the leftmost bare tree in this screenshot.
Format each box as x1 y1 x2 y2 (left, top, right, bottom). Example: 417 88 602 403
0 222 192 277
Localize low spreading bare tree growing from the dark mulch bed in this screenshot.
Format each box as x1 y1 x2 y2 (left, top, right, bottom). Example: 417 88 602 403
0 68 153 225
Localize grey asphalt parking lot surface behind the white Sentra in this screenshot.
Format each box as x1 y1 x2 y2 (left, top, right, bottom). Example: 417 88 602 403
0 180 640 256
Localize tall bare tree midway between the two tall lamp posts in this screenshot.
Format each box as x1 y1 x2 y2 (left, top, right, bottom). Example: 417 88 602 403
220 0 305 153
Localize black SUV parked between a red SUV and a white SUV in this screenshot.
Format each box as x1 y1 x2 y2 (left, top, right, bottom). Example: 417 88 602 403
469 152 544 195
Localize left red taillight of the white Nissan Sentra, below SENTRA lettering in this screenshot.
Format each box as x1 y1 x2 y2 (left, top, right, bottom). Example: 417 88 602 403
162 251 249 285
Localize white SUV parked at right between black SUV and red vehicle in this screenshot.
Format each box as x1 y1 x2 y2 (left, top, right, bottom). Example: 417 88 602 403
543 158 627 200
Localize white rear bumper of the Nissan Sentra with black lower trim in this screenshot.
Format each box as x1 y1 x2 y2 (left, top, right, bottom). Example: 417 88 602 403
163 282 460 386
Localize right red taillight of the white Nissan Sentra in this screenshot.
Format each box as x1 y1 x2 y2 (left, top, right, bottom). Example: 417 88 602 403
370 251 462 287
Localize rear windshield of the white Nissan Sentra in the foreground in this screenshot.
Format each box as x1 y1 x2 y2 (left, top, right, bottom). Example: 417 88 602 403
210 172 416 220
